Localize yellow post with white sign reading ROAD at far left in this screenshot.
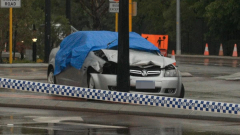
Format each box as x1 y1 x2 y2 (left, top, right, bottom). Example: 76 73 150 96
1 0 21 64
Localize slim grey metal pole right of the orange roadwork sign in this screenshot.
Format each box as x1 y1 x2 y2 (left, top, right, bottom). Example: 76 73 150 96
176 0 181 55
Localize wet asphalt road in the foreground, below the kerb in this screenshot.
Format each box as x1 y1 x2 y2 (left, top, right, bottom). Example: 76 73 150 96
0 107 240 135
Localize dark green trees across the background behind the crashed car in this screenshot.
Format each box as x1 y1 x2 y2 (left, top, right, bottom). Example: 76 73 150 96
0 0 240 59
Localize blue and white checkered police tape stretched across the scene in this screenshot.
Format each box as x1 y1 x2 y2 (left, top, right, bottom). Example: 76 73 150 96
0 78 240 115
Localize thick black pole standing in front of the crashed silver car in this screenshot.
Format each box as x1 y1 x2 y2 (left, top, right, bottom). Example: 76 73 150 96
117 0 130 92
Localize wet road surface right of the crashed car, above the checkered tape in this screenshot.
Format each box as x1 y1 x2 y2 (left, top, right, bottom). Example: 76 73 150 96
176 58 240 104
